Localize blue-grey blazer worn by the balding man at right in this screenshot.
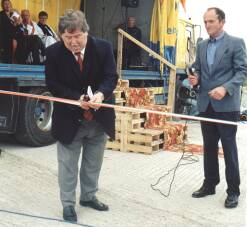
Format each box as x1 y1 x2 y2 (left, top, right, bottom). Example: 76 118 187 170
194 32 247 112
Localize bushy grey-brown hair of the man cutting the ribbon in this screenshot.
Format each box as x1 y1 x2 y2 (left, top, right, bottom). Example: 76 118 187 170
58 9 89 34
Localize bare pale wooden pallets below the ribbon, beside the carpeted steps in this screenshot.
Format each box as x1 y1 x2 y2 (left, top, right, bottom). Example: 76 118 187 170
106 112 164 154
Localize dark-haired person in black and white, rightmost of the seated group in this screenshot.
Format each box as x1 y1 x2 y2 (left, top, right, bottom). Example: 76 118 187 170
38 11 59 47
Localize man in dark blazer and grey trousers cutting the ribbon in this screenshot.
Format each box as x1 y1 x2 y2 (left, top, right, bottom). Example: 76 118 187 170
45 10 117 222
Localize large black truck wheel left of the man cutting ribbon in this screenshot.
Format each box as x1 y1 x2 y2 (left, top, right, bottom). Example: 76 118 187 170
15 87 55 147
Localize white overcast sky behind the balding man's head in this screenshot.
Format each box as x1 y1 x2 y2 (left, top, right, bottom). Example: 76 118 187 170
181 0 247 45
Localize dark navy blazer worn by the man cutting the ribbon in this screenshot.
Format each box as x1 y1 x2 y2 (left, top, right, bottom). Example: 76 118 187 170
45 36 117 143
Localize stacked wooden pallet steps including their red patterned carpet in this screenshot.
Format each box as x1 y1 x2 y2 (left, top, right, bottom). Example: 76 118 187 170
106 83 186 154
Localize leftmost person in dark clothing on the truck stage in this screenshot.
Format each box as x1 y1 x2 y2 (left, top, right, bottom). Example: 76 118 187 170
0 0 20 63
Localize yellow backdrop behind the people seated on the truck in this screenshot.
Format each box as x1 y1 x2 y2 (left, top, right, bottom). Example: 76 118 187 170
11 0 81 31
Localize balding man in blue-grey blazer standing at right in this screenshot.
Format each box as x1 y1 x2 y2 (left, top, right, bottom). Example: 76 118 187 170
188 7 247 208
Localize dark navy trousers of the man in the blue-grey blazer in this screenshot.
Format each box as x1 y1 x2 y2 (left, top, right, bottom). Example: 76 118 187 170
200 104 240 195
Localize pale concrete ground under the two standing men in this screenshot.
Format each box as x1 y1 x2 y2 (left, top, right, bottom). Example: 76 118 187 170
0 122 247 227
